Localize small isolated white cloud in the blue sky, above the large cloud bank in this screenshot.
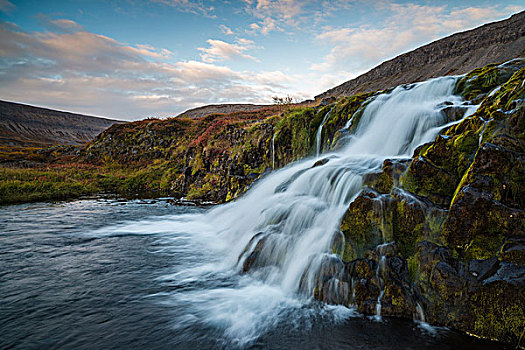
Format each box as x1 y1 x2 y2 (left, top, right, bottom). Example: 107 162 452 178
198 39 258 63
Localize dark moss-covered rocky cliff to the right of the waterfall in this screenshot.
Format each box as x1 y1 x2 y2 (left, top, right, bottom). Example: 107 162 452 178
324 60 525 346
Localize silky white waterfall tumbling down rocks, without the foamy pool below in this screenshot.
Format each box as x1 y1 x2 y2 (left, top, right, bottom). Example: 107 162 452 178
207 77 460 292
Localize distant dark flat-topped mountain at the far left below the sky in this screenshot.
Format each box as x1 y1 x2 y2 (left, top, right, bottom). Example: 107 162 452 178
0 101 123 147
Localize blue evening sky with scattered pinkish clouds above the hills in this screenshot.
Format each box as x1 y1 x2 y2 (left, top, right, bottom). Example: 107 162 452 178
0 0 525 120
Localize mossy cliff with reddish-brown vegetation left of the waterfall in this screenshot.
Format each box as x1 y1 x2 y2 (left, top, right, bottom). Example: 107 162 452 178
81 94 370 203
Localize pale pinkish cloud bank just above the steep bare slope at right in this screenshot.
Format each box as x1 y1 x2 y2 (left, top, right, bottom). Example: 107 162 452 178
310 2 512 73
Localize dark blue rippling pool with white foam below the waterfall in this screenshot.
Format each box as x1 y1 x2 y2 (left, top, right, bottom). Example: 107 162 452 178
0 199 508 349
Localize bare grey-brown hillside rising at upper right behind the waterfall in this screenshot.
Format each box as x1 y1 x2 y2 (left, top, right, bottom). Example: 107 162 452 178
315 11 525 100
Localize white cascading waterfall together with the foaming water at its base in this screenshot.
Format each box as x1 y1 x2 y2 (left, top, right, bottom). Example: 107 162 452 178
96 77 468 344
